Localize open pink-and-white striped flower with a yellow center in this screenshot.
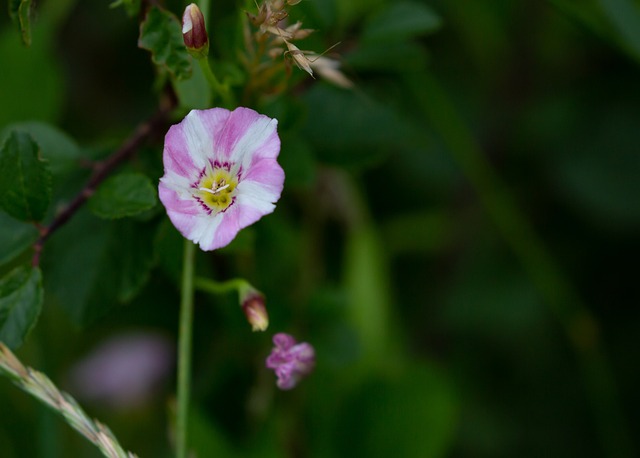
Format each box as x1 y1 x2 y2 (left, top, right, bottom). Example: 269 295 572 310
159 107 284 251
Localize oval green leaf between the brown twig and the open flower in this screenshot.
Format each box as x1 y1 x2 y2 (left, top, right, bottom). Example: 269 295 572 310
89 173 158 219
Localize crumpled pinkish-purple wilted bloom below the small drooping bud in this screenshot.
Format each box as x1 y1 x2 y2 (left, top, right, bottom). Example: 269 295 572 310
267 333 316 390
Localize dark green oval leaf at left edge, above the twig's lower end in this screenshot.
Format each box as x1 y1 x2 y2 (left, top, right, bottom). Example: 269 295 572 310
0 131 51 221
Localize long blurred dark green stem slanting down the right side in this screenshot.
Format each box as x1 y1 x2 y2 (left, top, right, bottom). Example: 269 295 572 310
406 73 633 458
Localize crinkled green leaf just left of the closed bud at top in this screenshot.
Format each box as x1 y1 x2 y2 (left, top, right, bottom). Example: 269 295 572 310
138 6 191 80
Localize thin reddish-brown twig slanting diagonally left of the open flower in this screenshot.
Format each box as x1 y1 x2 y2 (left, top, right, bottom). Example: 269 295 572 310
31 94 176 267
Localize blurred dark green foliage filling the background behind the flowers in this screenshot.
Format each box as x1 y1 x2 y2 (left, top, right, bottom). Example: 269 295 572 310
0 0 640 458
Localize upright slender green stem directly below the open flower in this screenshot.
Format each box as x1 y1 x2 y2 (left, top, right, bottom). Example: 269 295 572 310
176 240 195 458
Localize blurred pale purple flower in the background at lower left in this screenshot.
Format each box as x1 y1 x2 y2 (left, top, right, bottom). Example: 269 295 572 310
70 333 174 408
